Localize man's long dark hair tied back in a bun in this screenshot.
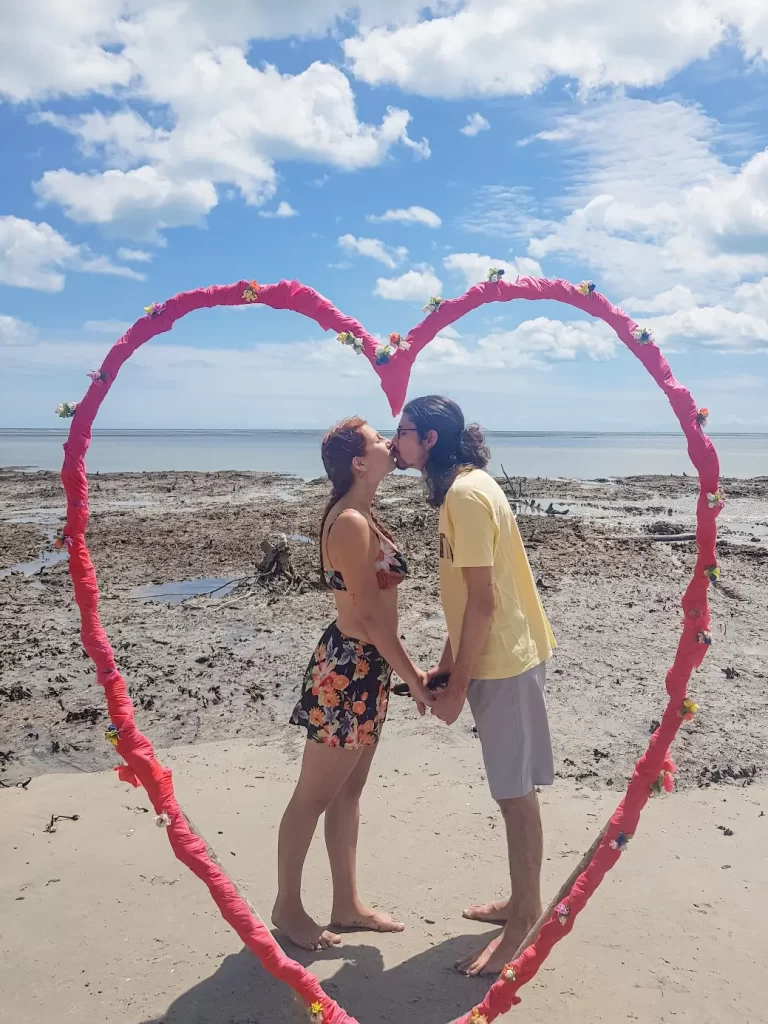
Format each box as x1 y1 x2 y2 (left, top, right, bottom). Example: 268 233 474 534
402 394 490 508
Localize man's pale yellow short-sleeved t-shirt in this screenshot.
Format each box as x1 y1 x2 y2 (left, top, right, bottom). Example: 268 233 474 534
439 469 555 679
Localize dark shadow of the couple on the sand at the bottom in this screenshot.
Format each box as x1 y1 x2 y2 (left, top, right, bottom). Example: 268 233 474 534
142 935 493 1024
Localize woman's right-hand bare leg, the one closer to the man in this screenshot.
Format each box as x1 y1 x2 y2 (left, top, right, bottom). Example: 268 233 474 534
326 746 404 932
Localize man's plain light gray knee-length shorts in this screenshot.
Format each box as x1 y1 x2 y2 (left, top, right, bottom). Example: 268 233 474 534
468 663 555 801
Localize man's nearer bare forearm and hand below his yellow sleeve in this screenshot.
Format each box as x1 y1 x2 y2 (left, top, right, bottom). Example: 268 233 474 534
430 565 496 725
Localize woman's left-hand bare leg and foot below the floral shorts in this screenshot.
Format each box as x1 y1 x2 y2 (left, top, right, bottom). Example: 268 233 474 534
272 740 362 949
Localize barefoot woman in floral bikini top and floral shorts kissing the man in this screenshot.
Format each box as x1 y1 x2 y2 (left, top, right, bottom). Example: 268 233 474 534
272 417 432 949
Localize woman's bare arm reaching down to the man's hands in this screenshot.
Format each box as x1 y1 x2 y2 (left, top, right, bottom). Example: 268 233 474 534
327 509 432 705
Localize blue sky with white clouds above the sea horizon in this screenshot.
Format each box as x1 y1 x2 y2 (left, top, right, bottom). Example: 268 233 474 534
0 0 768 431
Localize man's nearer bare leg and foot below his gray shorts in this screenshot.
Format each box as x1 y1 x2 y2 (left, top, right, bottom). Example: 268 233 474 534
457 791 544 977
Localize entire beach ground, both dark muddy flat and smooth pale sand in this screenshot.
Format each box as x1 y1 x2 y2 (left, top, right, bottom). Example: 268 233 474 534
0 471 768 1024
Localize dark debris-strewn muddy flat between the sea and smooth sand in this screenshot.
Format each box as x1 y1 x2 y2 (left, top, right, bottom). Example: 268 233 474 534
0 470 768 788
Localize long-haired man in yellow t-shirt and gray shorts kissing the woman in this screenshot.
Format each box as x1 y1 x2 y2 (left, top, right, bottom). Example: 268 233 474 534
395 395 555 976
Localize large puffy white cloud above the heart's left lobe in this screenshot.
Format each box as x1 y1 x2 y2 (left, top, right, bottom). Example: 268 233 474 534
28 37 429 241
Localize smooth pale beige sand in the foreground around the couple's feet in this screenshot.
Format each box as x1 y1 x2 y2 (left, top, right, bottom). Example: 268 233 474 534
0 741 768 1024
